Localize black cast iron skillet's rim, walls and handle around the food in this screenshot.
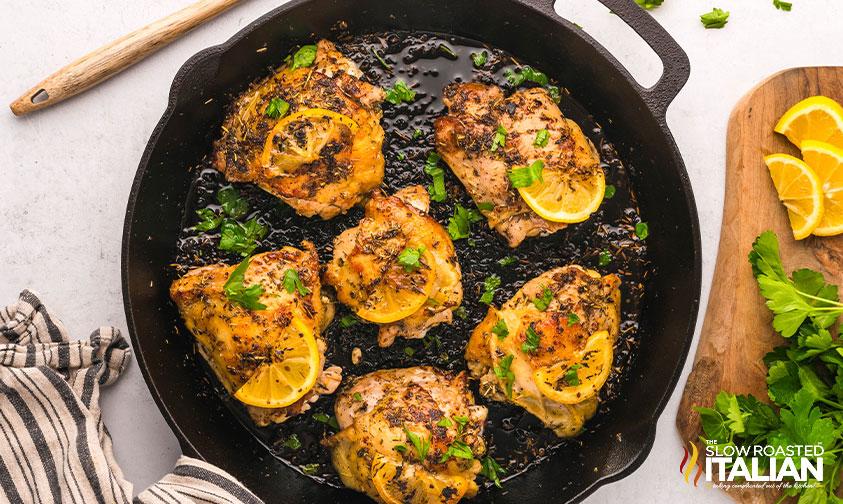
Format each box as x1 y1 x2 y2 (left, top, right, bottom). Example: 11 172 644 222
122 0 701 503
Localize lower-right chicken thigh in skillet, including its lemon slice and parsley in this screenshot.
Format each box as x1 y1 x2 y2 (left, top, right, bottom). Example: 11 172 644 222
465 266 621 437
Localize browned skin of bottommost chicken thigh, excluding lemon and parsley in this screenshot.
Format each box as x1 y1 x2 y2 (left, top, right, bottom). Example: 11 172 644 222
324 367 488 503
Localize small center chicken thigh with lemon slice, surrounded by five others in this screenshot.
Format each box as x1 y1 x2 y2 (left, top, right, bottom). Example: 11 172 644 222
324 186 462 347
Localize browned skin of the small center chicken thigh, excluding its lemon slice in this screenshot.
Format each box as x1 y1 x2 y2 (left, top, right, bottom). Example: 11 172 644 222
323 186 462 347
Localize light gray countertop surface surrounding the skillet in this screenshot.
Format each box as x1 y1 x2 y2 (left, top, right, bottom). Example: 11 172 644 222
0 0 843 503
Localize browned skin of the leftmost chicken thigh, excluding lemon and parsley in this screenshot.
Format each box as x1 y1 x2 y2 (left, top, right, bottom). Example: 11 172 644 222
170 242 342 426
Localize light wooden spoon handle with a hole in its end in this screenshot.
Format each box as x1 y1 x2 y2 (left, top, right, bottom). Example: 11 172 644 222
9 0 243 116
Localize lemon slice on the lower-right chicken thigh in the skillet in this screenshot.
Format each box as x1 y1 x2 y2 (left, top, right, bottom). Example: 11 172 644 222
533 331 614 404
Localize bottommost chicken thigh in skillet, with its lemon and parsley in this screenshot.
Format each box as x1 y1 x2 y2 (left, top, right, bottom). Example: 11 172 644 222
324 367 487 504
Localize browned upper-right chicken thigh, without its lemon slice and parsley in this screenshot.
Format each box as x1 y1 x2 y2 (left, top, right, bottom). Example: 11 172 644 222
434 82 601 247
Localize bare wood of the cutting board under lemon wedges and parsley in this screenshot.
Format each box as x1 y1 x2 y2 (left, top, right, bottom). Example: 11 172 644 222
676 67 843 504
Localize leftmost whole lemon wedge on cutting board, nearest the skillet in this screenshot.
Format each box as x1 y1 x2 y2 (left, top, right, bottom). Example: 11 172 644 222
764 154 823 240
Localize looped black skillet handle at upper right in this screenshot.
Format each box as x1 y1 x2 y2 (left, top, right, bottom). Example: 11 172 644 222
599 0 691 121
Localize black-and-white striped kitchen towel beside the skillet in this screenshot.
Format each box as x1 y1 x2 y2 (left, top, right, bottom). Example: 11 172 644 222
0 291 261 504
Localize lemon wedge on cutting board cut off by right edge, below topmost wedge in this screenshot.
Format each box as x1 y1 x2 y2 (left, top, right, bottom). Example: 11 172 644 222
802 140 843 236
